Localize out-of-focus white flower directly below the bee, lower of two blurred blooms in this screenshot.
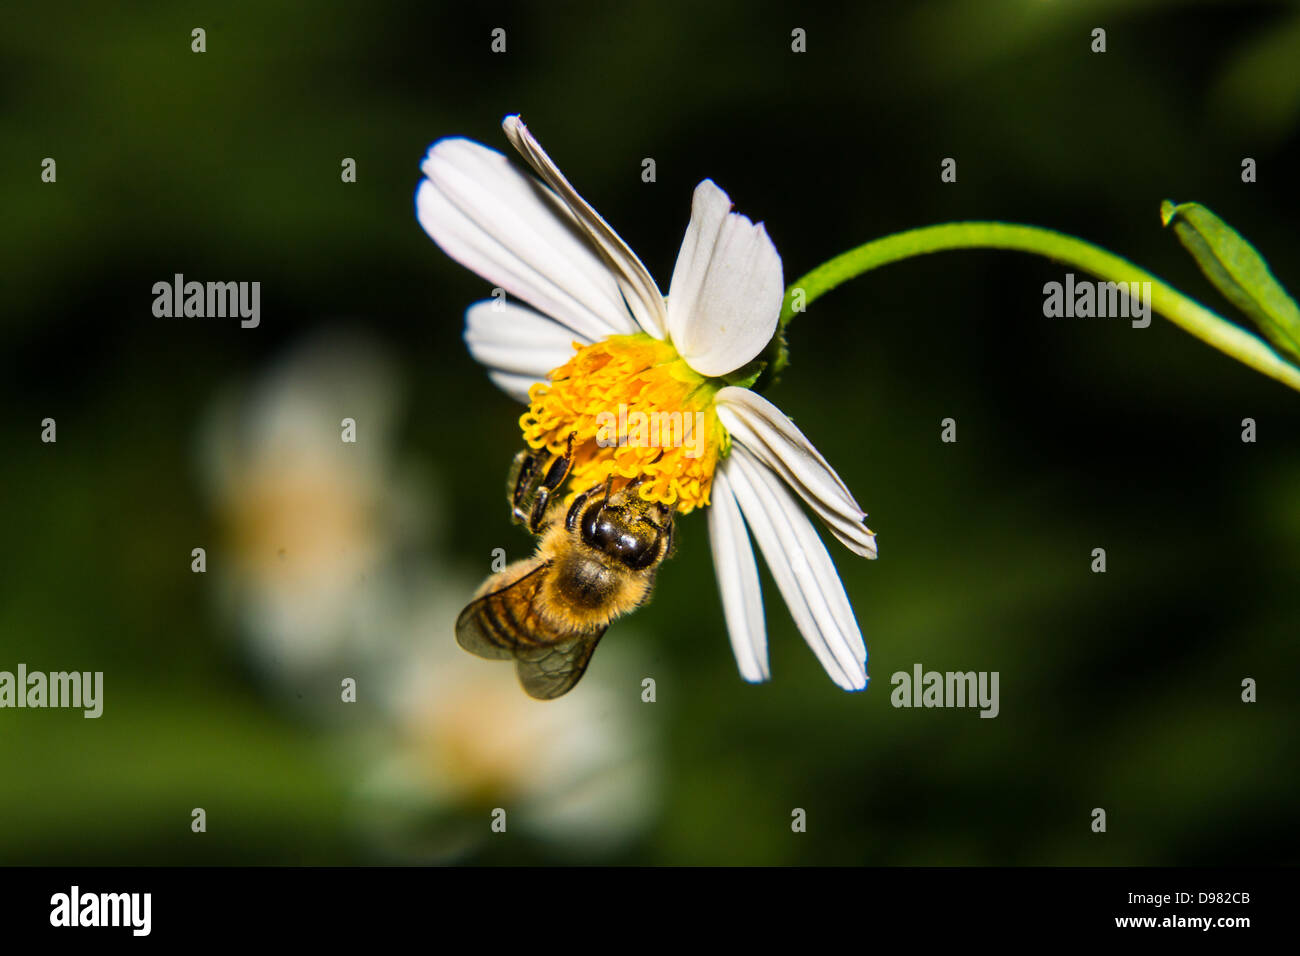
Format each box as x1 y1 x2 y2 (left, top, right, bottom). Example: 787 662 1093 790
363 579 658 861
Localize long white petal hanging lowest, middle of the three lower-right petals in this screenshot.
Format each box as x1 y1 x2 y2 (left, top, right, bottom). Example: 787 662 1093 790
724 445 867 691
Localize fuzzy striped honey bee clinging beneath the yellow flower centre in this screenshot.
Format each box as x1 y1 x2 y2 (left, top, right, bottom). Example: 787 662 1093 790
456 436 673 700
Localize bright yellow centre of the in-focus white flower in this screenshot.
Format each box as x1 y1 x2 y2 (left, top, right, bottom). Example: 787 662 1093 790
519 333 729 514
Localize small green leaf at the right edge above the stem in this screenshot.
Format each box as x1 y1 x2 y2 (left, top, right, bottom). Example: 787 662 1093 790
1160 199 1300 363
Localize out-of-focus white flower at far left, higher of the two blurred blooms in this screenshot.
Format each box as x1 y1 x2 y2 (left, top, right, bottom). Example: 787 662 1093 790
202 338 429 674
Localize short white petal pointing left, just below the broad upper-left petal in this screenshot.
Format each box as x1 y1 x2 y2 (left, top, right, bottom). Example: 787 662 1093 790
465 299 589 381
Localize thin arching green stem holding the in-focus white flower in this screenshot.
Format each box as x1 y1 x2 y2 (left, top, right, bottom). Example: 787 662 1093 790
771 222 1300 392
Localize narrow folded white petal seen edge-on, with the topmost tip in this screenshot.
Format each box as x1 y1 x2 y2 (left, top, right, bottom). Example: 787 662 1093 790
501 116 667 338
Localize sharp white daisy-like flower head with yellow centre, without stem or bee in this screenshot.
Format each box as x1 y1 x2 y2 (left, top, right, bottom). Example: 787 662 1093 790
415 116 876 691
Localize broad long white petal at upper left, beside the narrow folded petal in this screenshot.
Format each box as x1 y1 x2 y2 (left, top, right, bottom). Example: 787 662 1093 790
415 138 637 339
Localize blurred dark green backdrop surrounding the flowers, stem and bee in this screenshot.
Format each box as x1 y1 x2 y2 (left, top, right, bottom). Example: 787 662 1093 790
0 0 1300 865
